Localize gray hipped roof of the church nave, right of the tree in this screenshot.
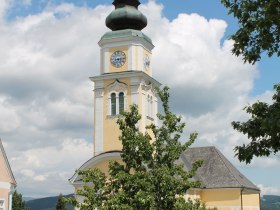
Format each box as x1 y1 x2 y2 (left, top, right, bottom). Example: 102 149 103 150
179 147 259 191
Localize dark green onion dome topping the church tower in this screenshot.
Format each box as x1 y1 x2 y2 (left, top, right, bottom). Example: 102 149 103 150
106 0 147 31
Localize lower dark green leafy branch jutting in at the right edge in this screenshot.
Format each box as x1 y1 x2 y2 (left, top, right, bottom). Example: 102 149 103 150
232 84 280 163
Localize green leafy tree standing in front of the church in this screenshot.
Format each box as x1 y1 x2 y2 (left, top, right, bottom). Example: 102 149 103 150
66 87 205 210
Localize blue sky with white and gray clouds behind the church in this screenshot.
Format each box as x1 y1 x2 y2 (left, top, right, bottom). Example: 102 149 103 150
0 0 280 197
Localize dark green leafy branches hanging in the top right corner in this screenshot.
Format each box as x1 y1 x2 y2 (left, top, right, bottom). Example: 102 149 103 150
221 0 280 64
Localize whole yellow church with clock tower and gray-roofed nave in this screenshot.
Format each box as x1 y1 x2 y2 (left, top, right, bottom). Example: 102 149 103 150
69 0 260 210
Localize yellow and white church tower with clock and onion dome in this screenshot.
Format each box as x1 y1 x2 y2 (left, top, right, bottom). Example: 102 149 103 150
90 0 160 156
